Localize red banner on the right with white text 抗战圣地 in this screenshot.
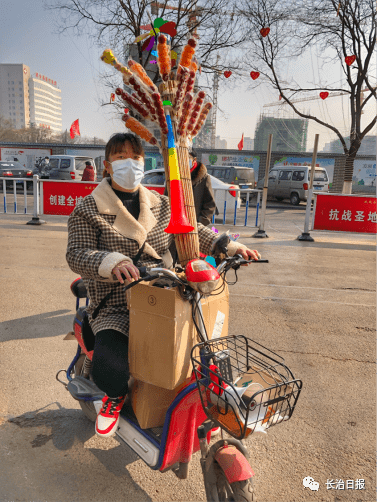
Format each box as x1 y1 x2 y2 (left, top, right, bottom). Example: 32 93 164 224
313 194 377 234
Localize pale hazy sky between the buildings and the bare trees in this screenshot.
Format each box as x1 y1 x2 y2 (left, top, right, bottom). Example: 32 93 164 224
0 0 376 151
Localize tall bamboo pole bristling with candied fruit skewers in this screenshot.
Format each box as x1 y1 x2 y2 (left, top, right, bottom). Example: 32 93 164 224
101 35 212 267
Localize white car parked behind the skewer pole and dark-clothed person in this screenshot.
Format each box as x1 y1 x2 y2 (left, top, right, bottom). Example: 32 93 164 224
141 169 241 214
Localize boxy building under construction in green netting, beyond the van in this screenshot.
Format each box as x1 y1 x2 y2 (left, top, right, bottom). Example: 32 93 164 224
254 115 308 152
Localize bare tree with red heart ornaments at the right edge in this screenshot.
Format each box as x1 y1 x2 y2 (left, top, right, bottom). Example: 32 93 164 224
239 0 377 193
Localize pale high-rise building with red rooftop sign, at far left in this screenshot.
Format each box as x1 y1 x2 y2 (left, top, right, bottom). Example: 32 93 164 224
0 64 62 132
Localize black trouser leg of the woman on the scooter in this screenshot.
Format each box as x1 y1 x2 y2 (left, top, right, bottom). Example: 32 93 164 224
92 329 130 397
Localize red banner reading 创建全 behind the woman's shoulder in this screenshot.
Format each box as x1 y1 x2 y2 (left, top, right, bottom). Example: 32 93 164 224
43 181 98 216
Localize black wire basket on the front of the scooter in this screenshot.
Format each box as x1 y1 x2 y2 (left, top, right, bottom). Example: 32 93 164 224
191 336 302 439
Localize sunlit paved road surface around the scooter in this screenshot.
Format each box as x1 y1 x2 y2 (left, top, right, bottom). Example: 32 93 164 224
0 208 376 502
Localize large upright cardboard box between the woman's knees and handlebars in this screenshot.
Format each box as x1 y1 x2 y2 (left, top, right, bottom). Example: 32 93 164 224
128 284 229 390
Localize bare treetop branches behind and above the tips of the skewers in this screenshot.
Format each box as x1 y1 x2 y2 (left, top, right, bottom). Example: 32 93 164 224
48 0 243 78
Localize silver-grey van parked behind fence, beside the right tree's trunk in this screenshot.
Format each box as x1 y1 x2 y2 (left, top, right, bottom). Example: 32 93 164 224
257 166 329 206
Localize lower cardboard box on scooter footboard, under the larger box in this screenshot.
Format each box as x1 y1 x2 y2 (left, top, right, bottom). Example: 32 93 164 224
131 379 190 429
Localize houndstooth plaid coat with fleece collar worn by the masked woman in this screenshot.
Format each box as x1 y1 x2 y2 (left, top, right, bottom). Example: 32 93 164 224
66 178 242 335
